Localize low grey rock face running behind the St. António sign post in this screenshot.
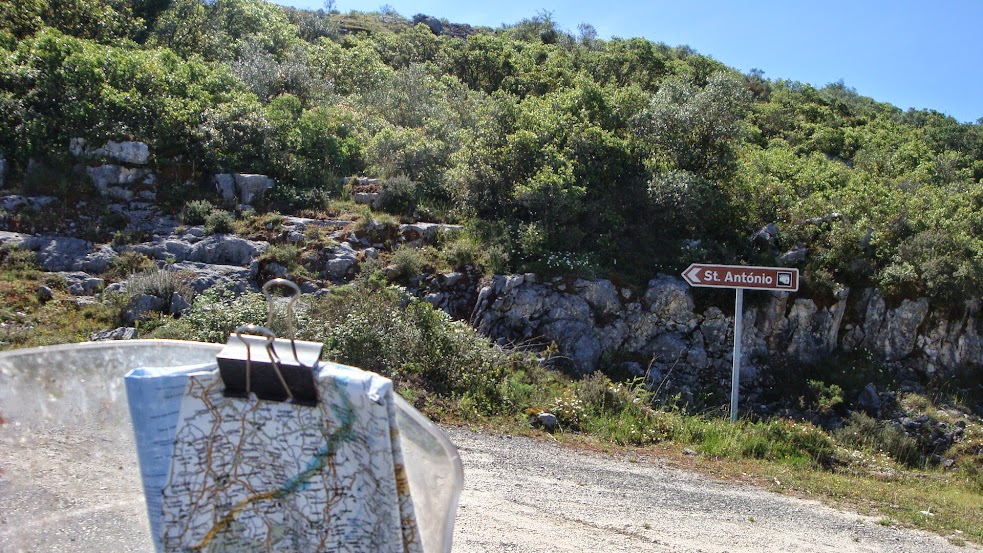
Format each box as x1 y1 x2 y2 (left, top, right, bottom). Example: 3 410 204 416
472 275 983 387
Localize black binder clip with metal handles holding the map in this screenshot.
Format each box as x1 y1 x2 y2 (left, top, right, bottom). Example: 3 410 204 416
217 278 324 406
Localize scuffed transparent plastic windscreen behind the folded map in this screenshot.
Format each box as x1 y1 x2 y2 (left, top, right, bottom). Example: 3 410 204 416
0 340 463 552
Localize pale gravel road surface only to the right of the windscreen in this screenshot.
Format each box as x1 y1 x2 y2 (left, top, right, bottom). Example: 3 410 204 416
448 429 983 553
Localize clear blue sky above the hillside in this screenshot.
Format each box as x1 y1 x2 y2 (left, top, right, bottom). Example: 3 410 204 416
277 0 983 122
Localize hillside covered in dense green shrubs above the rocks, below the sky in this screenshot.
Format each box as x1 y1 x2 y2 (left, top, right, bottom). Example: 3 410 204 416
0 0 983 305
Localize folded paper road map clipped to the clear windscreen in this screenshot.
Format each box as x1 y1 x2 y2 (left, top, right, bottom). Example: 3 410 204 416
127 365 422 552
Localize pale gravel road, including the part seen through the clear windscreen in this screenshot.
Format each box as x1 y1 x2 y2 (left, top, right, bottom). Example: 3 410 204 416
0 421 983 553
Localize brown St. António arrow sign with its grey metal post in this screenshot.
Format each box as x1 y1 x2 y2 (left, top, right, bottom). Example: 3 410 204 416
683 263 799 421
